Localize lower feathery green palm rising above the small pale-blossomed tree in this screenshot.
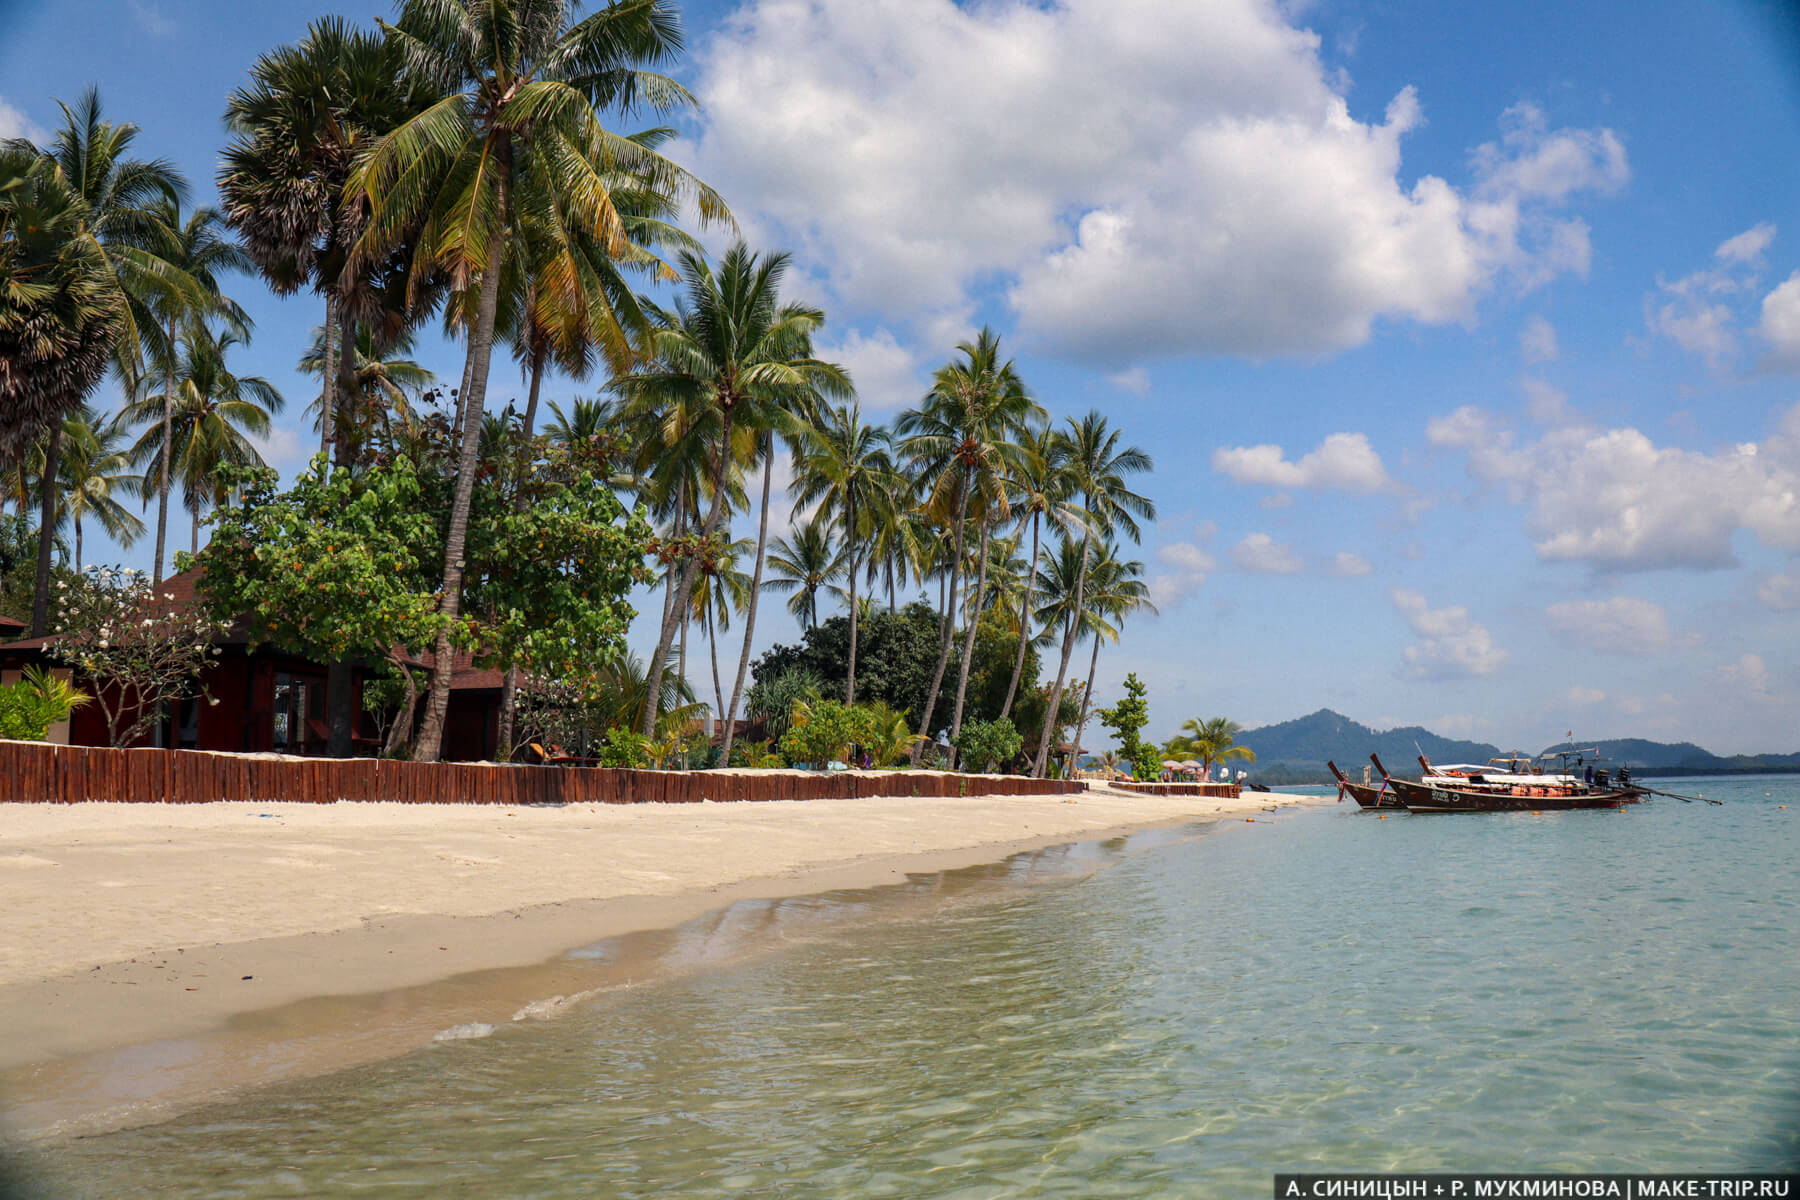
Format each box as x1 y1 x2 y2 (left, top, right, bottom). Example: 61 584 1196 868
122 327 283 552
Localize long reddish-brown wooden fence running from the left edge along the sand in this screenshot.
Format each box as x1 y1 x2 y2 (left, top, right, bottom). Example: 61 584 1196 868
0 741 1087 804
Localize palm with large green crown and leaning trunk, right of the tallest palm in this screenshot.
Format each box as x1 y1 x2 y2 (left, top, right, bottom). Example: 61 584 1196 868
617 243 851 734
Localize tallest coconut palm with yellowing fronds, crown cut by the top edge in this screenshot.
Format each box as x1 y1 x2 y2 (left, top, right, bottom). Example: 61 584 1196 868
347 0 729 761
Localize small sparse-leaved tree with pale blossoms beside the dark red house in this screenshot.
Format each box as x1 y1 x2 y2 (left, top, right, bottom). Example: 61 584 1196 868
49 567 227 747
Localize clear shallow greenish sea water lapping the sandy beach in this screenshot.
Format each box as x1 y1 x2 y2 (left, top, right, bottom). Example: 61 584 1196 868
7 777 1800 1200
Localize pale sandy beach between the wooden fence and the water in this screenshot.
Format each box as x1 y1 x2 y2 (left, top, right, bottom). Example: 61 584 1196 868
0 790 1330 1139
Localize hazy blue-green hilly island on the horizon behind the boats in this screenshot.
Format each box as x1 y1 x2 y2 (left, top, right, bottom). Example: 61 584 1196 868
1238 709 1800 786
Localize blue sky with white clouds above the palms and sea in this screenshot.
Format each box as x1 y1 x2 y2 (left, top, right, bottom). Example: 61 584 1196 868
0 0 1800 752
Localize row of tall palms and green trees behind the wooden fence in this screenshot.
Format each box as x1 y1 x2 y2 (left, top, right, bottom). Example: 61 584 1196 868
0 0 1156 774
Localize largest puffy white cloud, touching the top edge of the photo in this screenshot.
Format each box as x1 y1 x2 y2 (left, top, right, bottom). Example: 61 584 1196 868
693 0 1629 367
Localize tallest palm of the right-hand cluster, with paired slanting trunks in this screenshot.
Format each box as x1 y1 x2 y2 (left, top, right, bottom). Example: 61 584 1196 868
895 327 1044 755
